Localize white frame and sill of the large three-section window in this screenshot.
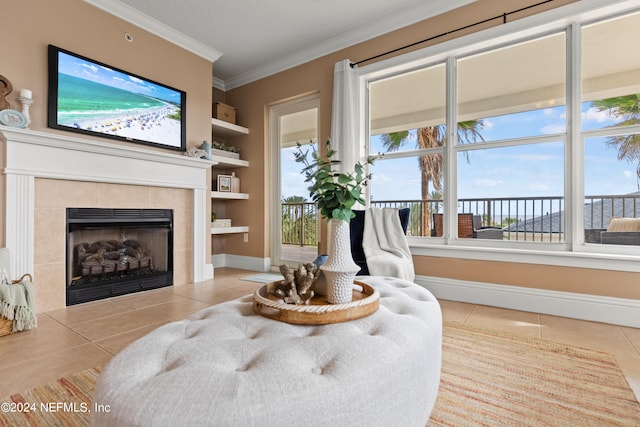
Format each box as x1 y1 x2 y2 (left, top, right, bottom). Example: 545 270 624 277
358 0 640 272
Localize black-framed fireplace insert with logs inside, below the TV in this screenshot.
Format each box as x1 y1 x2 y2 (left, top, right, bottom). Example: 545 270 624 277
66 208 173 306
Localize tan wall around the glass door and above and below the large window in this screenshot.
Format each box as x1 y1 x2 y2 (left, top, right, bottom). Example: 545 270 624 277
226 0 640 299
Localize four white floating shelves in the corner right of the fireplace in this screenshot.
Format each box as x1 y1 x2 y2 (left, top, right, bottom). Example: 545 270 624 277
211 118 249 235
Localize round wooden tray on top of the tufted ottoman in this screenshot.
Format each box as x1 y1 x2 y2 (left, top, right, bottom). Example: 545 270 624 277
253 281 380 325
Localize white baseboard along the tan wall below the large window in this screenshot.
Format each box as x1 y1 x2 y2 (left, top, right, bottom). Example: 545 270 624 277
415 276 640 328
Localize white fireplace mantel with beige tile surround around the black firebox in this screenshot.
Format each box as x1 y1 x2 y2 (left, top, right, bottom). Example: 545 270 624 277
0 126 213 312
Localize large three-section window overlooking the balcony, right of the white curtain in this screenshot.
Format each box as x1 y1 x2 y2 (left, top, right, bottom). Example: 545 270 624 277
361 3 640 252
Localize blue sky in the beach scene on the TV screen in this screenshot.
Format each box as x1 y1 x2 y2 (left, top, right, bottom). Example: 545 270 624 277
58 52 180 104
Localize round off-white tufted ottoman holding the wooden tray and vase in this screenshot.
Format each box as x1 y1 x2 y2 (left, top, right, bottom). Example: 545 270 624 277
92 276 442 427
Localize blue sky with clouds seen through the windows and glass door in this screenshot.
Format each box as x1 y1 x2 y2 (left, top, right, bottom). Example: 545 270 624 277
281 104 638 201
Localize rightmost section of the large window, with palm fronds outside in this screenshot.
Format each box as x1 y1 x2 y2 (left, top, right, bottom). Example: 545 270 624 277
581 13 640 244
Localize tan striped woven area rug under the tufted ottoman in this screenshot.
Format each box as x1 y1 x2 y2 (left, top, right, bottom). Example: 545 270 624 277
0 323 640 427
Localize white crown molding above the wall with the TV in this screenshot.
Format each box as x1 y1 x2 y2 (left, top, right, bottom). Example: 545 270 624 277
83 0 222 62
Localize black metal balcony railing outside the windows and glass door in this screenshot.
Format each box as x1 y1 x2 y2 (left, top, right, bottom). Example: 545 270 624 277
282 194 640 246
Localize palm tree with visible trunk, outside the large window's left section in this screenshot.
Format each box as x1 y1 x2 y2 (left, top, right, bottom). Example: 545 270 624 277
381 120 484 235
